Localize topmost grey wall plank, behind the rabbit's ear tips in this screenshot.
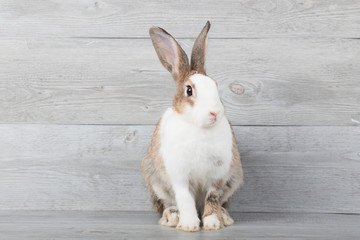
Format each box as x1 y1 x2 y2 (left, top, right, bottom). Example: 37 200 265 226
0 0 360 38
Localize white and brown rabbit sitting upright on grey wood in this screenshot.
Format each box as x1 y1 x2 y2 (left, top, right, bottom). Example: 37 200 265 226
142 22 243 231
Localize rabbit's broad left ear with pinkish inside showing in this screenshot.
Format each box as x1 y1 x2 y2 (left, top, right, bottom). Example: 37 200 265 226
149 27 190 81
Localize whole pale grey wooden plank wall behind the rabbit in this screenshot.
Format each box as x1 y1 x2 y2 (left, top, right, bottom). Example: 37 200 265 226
0 0 360 213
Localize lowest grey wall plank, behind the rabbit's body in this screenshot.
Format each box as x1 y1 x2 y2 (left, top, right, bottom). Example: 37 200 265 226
0 124 360 213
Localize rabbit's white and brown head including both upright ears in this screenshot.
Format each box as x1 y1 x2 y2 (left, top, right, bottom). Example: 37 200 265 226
149 22 224 127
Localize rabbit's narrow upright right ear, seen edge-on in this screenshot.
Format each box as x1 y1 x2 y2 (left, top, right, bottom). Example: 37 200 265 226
191 21 210 75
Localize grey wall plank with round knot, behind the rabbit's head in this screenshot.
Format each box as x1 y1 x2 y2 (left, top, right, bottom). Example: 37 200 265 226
0 38 360 125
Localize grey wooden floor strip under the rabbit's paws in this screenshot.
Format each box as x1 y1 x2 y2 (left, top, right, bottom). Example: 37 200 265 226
0 211 360 240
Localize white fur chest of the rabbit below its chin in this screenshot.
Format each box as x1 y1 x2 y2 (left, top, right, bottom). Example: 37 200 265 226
160 109 232 186
